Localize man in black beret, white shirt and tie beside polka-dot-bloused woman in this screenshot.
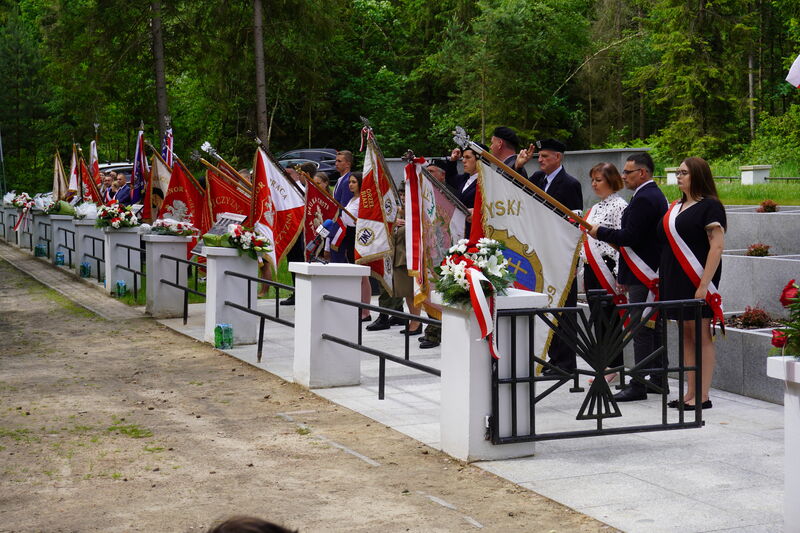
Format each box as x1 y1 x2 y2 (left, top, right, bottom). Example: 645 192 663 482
530 139 583 375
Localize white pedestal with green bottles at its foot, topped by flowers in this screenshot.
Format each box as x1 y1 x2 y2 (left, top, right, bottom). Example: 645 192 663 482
203 246 259 344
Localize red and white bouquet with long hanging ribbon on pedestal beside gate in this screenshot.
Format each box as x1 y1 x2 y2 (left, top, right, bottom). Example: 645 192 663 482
435 238 514 359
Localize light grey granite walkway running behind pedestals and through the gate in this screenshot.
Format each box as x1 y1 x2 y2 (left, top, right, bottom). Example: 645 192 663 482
0 239 784 532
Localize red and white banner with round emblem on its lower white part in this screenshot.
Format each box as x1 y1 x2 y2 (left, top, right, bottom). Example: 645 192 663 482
355 136 397 295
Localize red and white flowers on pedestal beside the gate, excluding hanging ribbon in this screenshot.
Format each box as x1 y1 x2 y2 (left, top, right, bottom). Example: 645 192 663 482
435 238 514 304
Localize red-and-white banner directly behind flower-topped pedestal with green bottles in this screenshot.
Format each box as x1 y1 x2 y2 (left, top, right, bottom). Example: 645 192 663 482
253 148 305 272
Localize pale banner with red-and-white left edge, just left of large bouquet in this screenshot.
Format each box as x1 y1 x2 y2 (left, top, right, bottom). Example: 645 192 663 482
405 160 466 318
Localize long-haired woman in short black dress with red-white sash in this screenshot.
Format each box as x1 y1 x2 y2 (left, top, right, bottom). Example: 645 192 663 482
658 157 727 409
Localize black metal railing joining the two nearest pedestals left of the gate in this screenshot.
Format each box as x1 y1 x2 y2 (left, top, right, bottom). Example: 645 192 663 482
322 294 442 400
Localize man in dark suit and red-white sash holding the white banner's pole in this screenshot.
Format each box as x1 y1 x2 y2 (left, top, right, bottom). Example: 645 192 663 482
589 152 668 402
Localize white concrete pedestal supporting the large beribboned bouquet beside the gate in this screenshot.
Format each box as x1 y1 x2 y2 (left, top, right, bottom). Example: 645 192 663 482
437 289 547 461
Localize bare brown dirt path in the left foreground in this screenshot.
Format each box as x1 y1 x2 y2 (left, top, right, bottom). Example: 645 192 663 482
0 260 611 532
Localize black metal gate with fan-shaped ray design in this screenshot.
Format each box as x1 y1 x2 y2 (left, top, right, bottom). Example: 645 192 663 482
487 291 704 444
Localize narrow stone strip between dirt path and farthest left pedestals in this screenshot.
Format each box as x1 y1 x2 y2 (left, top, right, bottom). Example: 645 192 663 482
0 241 144 320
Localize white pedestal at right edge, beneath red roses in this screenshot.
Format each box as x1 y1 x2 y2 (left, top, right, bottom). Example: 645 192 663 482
767 357 800 531
